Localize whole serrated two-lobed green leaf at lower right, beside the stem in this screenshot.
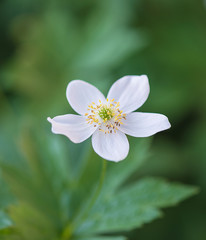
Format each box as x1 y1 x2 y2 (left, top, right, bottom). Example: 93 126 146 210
78 178 198 233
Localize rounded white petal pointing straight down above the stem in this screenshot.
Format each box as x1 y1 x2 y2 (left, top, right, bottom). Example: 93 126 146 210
92 130 129 162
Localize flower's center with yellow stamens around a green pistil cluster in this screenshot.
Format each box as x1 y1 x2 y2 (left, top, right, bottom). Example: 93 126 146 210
85 99 126 134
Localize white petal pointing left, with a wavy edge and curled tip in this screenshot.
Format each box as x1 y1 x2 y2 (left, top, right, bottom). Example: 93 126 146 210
47 114 98 143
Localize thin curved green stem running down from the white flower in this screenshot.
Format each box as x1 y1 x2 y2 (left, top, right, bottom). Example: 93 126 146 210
61 160 107 240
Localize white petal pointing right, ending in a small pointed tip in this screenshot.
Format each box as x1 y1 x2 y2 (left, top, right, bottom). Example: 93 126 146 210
119 112 171 137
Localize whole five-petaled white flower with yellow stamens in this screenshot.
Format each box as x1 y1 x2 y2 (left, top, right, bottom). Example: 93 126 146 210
48 75 171 162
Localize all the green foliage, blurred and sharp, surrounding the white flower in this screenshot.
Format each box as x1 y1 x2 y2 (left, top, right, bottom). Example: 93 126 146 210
0 0 206 240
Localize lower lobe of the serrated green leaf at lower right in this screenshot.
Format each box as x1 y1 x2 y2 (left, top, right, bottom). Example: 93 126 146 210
77 206 162 234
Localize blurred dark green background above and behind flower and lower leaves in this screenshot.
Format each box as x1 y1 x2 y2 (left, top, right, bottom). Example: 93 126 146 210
0 0 206 240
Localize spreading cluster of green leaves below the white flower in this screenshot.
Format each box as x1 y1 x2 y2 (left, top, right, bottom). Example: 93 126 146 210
0 134 197 240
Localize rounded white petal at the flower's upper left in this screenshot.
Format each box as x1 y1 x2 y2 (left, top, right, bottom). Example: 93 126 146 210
66 80 105 115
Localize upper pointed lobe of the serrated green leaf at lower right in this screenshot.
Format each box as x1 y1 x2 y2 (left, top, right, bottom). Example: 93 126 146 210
117 178 198 207
